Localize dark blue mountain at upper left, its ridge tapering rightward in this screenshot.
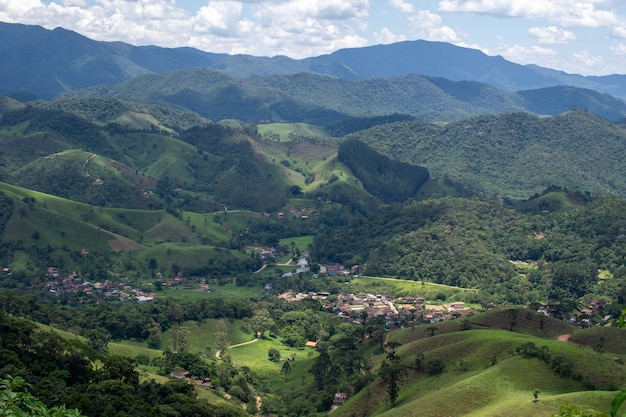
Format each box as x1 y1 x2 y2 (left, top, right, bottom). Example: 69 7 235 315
0 22 221 99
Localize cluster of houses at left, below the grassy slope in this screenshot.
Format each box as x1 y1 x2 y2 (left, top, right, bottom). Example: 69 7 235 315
46 267 155 303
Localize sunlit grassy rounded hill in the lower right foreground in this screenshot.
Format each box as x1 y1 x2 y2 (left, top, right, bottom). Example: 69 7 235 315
336 310 625 416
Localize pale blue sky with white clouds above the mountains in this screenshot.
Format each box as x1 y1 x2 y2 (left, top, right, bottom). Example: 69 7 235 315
0 0 626 75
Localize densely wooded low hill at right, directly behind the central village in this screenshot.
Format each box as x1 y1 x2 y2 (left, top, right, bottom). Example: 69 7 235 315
312 191 626 305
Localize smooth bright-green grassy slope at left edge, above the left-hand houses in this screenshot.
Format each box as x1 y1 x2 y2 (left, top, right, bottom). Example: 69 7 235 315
0 183 258 276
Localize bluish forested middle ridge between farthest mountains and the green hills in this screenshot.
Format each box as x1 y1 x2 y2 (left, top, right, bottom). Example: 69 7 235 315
75 68 626 125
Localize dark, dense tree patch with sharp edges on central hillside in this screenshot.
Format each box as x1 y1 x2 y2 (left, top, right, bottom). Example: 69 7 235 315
337 139 429 202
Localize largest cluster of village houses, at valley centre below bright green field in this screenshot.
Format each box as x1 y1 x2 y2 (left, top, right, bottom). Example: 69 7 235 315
279 292 473 323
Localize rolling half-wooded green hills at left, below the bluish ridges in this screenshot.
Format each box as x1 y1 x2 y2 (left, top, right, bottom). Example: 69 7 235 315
0 105 356 212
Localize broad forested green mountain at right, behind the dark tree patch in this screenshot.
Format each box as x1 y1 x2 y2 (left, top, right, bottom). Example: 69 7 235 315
347 110 626 199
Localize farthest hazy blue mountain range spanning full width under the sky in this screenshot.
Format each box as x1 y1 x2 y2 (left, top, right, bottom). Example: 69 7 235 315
0 23 626 98
